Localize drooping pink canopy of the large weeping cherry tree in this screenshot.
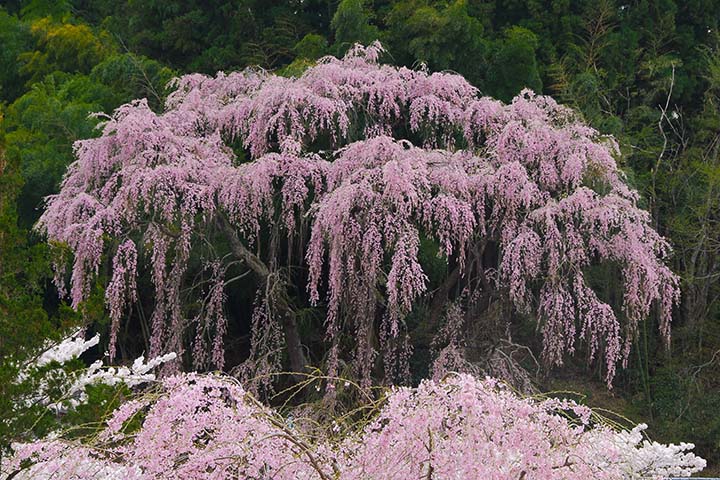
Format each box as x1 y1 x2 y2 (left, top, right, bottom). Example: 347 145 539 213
39 43 678 382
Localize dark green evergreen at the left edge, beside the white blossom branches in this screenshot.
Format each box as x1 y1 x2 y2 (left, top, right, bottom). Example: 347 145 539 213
0 112 93 457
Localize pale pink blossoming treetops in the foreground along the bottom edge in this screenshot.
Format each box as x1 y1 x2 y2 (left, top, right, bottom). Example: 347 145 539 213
0 374 705 480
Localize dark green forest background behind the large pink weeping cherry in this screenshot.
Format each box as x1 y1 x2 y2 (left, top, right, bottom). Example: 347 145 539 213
0 0 720 472
